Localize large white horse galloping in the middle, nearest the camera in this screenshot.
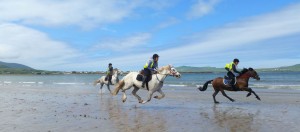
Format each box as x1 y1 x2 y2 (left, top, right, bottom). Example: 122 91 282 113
112 65 181 104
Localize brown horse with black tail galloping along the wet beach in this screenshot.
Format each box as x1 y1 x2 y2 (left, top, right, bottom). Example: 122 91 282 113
198 68 260 103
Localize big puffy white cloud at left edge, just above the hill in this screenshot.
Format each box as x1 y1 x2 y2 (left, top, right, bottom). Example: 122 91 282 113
0 23 80 69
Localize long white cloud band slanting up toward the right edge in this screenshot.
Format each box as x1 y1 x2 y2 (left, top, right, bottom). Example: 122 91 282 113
87 4 300 68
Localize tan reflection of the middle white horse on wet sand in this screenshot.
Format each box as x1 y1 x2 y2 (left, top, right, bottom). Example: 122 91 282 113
106 99 166 132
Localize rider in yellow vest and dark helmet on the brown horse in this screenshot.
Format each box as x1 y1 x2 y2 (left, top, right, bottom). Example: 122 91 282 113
225 58 241 91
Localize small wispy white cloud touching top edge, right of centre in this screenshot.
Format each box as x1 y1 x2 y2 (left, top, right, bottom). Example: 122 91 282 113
187 0 220 19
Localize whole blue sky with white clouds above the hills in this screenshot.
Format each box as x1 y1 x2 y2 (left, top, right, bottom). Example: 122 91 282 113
0 0 300 71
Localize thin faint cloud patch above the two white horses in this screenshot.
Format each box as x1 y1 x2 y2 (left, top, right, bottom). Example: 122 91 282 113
93 33 151 51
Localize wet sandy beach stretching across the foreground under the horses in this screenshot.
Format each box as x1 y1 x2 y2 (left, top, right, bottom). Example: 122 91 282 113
0 86 300 132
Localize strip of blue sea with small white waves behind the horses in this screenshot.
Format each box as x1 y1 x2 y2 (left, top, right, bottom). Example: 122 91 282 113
0 72 300 90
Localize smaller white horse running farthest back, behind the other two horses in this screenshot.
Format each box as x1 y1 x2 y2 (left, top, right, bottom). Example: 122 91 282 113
94 68 122 93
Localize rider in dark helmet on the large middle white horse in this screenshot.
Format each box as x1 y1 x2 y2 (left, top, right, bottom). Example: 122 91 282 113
142 54 159 91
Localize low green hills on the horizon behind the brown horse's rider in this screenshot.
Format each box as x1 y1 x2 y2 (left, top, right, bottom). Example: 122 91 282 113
176 64 300 73
